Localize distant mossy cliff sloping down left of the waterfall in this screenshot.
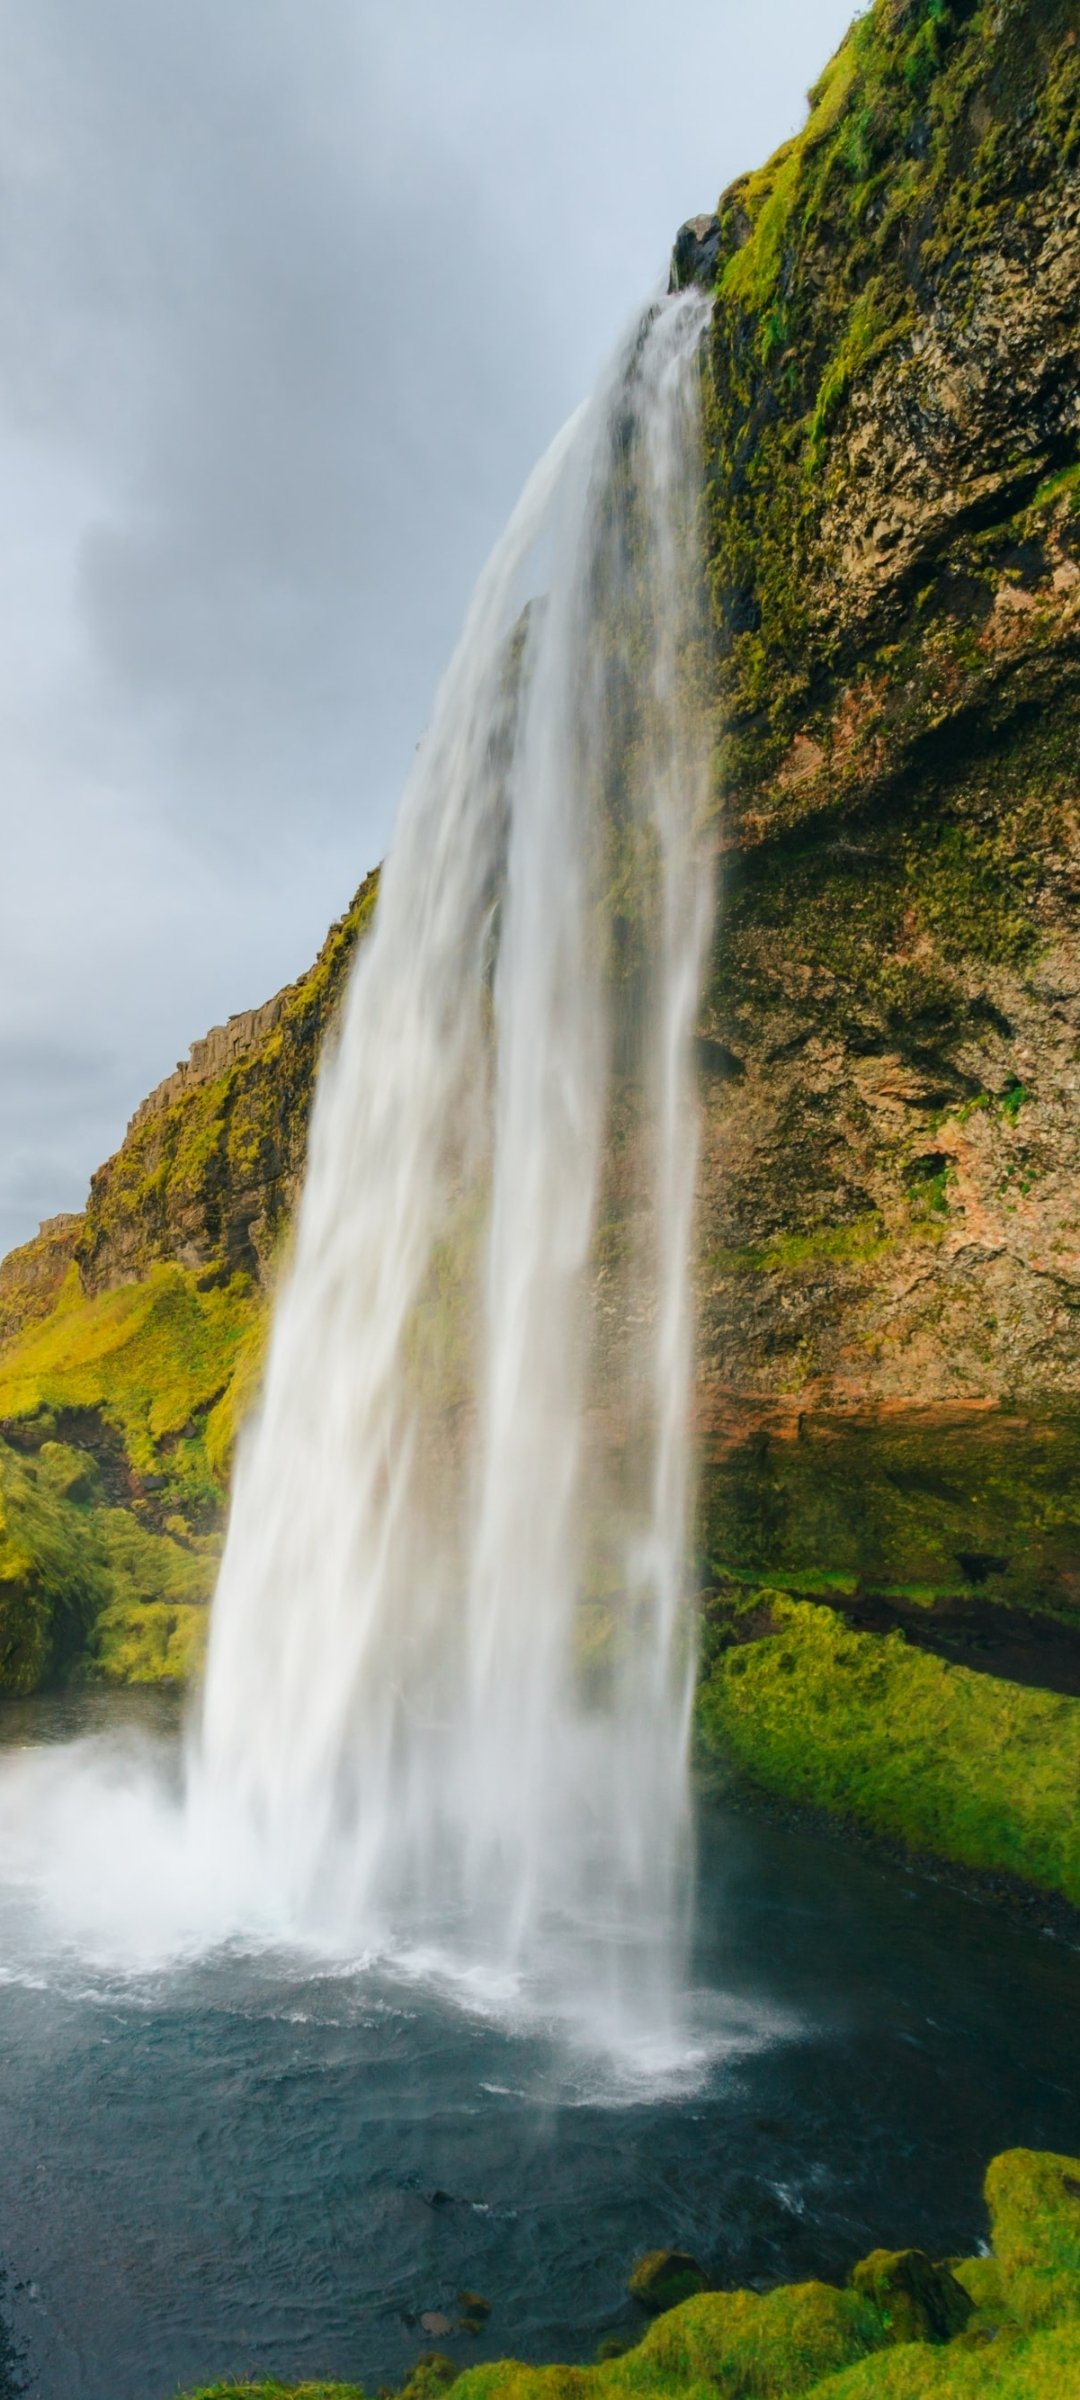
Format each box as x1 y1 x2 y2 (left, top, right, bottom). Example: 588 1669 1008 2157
0 876 377 1692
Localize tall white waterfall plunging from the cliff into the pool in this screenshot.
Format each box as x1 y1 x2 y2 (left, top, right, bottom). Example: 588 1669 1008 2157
190 293 713 2038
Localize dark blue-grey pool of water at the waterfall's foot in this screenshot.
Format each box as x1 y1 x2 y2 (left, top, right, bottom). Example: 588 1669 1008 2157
0 1704 1080 2400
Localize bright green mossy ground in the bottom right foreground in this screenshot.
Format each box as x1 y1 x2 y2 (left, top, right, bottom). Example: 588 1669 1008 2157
177 2150 1080 2400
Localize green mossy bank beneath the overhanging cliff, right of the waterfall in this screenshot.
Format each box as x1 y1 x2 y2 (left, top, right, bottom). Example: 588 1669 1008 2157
698 1594 1080 1906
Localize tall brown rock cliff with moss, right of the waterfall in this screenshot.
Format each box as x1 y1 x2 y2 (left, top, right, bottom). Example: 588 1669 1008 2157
677 0 1080 1606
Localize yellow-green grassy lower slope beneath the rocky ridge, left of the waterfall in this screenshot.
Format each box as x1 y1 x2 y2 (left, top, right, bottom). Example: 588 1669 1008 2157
0 1267 262 1692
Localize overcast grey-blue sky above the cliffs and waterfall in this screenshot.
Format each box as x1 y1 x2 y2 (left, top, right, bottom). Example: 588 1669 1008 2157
0 0 854 1253
